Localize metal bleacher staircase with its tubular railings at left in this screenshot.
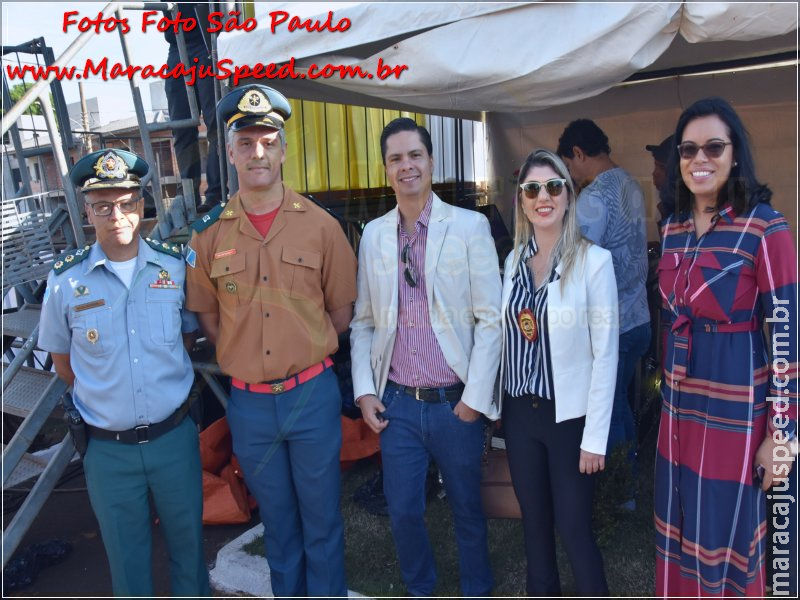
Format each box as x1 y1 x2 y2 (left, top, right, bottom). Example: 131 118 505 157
2 2 234 567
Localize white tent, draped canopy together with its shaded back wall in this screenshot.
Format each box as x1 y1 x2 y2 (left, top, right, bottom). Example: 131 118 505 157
219 2 798 239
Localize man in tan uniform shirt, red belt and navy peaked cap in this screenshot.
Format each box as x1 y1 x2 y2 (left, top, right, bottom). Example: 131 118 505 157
186 85 356 597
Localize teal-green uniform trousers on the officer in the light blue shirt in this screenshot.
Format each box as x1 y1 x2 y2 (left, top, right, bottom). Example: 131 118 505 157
83 419 211 597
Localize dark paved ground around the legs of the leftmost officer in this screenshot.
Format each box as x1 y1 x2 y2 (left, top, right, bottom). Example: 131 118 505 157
3 472 258 597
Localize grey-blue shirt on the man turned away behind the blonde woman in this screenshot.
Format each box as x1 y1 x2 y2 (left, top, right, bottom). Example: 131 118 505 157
577 167 650 334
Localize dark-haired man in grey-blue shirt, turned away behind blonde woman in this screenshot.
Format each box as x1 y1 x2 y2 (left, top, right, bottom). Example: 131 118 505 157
557 119 650 509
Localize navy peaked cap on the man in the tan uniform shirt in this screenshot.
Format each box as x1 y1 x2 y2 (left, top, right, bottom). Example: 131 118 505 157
217 85 292 131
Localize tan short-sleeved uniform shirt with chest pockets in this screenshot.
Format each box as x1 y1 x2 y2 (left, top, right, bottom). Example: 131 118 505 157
186 187 357 383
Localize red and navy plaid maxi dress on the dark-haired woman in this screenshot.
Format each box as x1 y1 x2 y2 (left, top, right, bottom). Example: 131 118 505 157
654 204 797 597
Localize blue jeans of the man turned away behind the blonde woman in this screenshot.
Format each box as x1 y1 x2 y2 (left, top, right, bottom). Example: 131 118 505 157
606 323 650 460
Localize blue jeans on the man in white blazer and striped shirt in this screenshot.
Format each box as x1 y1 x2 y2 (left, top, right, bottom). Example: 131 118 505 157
381 382 494 596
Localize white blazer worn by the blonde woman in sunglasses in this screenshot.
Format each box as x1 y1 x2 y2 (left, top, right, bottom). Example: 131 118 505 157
497 244 619 454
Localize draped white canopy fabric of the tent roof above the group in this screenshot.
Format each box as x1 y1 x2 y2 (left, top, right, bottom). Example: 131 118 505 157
219 2 797 116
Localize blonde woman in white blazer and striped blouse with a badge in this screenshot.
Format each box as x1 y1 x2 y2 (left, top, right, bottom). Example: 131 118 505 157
498 150 619 596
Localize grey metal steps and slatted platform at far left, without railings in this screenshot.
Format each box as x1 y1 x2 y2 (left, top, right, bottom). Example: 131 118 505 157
2 195 74 565
